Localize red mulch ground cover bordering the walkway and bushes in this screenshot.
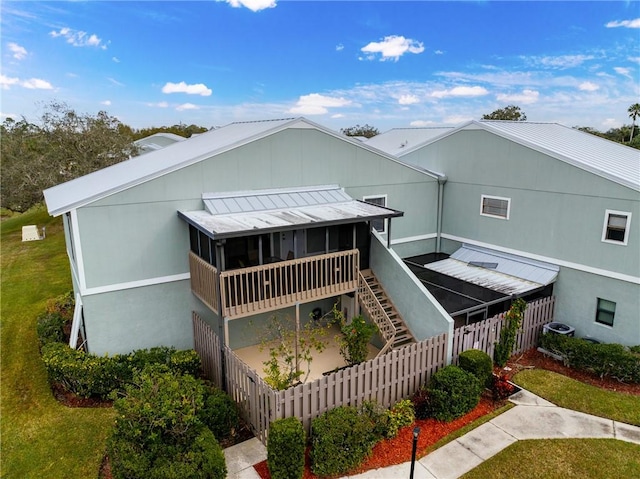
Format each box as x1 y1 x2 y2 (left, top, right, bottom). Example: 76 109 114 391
253 349 640 479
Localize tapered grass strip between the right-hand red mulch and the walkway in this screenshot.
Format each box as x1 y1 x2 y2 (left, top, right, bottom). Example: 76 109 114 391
513 369 640 426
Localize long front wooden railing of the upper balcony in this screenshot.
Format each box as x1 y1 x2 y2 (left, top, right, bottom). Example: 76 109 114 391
220 249 359 318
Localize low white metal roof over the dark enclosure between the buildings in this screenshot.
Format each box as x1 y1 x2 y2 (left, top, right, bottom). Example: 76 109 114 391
424 248 560 295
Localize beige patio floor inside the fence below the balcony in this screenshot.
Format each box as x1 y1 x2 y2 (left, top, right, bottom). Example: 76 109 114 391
233 325 380 382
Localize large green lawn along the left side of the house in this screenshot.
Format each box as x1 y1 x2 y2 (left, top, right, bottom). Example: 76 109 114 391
0 207 115 479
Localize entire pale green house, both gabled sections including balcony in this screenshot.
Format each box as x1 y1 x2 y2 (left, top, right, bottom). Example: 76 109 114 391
45 118 640 364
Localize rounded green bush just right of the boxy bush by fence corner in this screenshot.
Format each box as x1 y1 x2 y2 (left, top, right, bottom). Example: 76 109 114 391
311 406 378 476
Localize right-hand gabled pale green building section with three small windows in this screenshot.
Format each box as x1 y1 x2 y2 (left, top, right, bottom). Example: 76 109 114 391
376 121 640 345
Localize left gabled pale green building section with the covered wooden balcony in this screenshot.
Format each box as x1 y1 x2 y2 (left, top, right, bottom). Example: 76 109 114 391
44 118 453 355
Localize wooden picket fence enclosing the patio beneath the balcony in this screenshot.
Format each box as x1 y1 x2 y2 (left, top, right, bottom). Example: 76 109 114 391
193 313 447 442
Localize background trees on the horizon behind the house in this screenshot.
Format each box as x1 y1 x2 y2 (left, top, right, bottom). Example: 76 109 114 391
0 101 640 212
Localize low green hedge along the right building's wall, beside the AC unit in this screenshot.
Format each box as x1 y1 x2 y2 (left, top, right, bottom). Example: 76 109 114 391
540 333 640 383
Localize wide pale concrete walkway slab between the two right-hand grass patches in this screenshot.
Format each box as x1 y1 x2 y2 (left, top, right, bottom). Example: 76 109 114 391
490 406 614 439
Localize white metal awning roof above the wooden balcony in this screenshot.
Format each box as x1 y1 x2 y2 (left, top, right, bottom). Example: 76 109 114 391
178 185 404 239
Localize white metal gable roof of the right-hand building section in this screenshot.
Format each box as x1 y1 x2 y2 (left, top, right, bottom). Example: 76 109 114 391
398 120 640 191
